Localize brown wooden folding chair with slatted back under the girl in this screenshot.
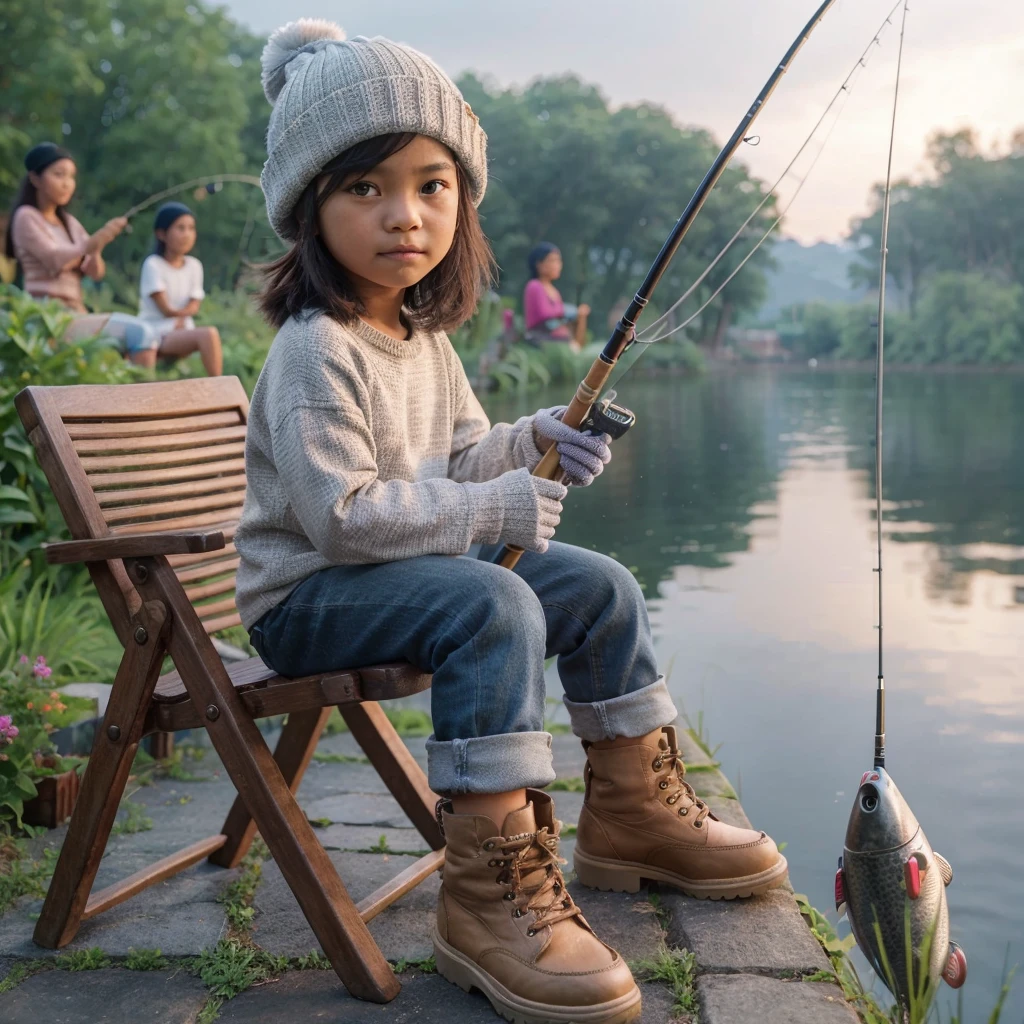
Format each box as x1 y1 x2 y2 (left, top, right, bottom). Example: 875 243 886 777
16 377 444 1002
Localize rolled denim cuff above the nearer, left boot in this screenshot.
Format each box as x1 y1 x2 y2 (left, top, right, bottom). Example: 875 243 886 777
427 732 555 797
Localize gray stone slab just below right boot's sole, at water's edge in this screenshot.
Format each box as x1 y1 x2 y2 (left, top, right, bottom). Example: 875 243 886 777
662 889 829 977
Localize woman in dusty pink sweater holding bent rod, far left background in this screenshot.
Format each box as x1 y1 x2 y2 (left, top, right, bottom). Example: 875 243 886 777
6 142 160 366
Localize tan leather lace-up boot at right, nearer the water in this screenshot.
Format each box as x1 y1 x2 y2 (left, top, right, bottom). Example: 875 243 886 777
574 725 786 899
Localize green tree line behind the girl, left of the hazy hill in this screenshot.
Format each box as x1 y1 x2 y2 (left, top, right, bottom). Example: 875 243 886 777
0 0 774 350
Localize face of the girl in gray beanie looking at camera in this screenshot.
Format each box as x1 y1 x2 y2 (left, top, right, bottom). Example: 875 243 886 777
317 135 459 293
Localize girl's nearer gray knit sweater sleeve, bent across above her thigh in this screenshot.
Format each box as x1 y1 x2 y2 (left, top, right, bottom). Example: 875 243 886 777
270 350 505 565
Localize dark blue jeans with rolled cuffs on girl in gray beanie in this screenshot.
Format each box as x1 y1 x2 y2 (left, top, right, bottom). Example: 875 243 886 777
250 542 677 795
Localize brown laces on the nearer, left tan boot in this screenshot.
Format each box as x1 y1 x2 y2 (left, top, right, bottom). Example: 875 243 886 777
489 827 581 937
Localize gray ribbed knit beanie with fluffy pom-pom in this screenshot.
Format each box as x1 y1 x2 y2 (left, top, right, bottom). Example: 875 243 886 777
261 17 487 240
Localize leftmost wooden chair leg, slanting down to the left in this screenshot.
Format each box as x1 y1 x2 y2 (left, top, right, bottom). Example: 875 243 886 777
33 601 167 949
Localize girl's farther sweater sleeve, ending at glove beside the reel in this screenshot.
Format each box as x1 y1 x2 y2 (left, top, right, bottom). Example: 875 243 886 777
449 339 541 481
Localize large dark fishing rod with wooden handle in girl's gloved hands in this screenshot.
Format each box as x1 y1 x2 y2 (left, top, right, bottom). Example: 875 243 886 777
495 0 836 568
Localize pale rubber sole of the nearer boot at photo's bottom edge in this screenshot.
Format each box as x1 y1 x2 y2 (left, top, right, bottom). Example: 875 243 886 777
431 928 641 1024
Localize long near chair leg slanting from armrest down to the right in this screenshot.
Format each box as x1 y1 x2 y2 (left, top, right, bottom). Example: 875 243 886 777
138 557 401 1002
